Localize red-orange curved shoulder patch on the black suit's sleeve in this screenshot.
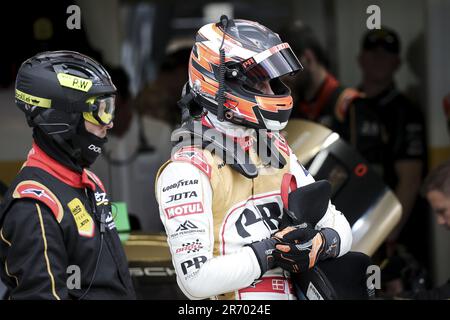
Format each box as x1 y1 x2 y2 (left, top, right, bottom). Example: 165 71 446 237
13 180 64 223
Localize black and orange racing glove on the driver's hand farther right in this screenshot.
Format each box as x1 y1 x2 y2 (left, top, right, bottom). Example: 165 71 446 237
271 223 340 273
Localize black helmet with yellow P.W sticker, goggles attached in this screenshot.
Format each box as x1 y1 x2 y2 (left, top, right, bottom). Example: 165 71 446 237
15 51 116 155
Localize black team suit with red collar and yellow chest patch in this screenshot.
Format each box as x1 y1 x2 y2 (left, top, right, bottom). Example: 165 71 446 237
0 144 135 300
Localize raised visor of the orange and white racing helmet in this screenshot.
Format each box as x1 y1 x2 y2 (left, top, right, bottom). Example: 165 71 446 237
241 43 303 83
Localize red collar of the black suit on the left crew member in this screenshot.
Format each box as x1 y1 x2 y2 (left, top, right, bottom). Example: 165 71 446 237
24 142 96 191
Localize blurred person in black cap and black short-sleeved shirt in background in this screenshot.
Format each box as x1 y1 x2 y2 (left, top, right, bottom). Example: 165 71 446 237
344 27 429 295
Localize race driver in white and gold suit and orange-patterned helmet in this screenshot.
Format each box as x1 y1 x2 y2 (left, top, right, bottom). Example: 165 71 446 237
156 16 352 300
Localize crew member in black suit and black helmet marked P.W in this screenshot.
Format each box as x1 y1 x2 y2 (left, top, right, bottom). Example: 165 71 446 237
0 51 135 300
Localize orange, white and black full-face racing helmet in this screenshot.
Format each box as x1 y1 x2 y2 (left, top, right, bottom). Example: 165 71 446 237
188 16 303 130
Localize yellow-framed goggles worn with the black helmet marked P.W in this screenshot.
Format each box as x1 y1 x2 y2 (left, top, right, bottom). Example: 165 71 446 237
83 95 116 126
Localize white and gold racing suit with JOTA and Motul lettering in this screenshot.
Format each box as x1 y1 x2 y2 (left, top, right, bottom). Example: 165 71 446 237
156 118 352 300
